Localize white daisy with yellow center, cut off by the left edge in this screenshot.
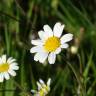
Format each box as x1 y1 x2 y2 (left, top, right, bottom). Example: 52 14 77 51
0 55 19 82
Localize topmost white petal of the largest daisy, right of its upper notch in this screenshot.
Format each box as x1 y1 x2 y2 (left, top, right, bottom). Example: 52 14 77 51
53 22 64 37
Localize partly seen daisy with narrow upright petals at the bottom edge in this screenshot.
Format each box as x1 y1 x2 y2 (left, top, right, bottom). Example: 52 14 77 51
31 78 51 96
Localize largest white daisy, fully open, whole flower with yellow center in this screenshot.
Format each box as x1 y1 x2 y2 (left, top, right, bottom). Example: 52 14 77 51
30 22 73 64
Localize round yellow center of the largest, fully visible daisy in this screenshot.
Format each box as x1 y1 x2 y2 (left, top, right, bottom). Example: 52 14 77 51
44 36 60 52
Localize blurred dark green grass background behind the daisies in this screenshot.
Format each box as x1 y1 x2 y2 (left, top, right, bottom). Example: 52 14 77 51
0 0 96 96
